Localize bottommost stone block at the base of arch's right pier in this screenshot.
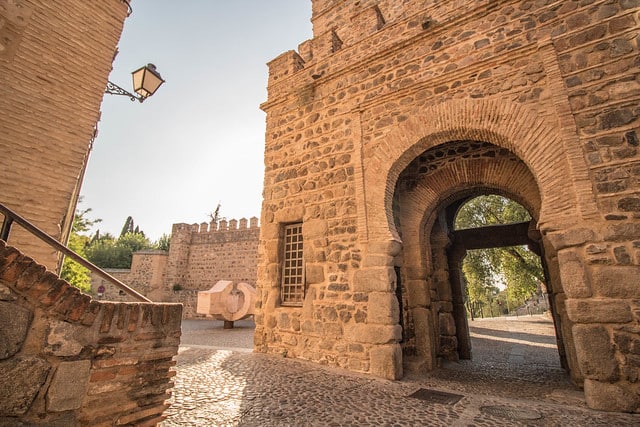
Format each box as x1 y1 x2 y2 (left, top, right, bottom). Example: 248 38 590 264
584 378 640 412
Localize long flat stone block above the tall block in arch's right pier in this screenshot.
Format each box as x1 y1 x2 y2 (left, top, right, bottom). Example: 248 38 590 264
565 298 633 323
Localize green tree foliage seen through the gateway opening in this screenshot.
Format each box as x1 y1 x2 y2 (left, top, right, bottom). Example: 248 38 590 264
455 195 544 316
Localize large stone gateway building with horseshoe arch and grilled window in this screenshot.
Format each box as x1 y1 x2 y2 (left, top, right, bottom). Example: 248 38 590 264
255 0 640 412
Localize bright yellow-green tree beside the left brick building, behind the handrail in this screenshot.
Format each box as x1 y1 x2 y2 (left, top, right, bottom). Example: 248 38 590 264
60 209 101 292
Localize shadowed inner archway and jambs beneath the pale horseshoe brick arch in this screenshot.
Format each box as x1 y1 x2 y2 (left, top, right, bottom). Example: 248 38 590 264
393 141 581 382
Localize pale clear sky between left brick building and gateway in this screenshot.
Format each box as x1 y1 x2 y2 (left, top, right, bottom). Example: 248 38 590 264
78 0 312 240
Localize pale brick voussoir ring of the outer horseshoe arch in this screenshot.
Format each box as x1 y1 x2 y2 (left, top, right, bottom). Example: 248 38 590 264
363 98 585 241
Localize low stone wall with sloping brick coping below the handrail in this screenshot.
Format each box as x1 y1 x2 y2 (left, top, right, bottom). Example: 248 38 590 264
0 241 181 426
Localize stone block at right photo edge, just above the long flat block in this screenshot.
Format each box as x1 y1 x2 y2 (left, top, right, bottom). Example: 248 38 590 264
591 265 640 298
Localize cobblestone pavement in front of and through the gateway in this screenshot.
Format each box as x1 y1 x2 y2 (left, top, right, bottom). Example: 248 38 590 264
162 316 640 427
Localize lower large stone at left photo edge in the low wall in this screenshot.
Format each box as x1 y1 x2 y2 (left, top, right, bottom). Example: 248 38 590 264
0 357 51 416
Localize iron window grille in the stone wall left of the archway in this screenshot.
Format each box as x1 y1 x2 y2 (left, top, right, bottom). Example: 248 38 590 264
280 223 305 306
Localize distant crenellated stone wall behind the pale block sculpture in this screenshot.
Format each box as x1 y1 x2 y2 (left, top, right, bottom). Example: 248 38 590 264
91 221 260 318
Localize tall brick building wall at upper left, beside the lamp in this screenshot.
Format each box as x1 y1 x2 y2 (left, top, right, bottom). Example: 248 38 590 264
0 0 128 271
